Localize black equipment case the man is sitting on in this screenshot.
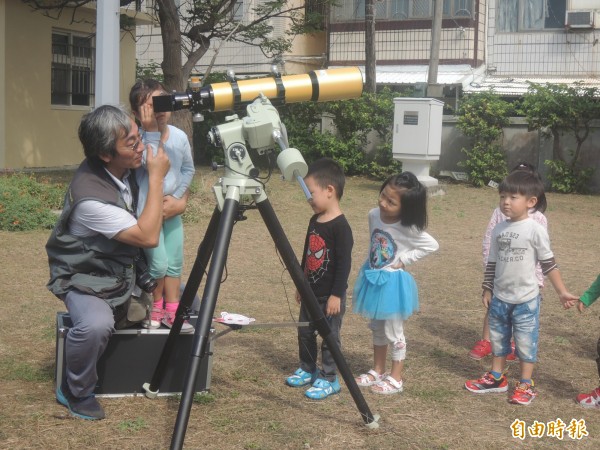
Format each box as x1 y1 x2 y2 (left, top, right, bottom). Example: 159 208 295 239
54 312 214 397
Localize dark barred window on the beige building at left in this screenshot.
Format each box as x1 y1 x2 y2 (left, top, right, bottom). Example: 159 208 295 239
51 31 95 106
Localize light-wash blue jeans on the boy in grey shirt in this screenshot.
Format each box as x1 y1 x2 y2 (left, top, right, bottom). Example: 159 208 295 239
489 295 540 363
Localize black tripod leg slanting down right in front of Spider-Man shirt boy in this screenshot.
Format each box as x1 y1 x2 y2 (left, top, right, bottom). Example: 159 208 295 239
258 199 378 427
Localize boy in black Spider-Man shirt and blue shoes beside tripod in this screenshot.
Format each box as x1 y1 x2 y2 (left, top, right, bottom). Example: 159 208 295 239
286 158 354 400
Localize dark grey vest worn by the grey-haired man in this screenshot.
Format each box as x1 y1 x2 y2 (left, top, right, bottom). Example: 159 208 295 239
46 160 139 308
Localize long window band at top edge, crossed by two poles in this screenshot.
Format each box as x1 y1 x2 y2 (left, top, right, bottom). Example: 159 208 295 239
331 0 473 22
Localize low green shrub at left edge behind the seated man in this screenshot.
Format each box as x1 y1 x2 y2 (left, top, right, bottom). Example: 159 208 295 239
0 174 65 231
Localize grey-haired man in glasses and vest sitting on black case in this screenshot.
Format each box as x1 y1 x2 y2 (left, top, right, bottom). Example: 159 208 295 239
46 105 176 420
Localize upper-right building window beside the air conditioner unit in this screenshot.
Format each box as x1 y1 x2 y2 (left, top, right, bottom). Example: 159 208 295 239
496 0 567 32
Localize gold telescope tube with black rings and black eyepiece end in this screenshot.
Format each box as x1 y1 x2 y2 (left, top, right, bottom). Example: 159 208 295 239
152 67 363 114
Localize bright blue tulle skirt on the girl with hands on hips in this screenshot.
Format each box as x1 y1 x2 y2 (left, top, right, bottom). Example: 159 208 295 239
352 263 419 320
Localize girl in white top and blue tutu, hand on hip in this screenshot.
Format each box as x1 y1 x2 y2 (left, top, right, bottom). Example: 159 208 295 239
353 172 439 394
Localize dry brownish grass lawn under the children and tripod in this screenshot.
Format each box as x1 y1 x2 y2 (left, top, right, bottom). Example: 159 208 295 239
0 169 600 450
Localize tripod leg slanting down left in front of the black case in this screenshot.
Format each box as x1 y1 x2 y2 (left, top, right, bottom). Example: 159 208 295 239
143 208 221 398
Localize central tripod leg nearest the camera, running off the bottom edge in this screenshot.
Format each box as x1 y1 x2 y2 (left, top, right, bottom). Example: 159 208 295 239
171 186 240 449
